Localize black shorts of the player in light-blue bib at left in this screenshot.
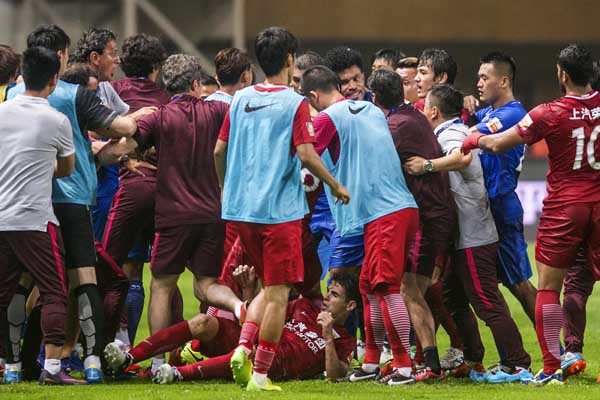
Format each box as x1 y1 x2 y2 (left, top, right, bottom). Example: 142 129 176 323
53 203 96 269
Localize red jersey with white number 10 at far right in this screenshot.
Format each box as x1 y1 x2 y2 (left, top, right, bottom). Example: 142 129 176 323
516 91 600 205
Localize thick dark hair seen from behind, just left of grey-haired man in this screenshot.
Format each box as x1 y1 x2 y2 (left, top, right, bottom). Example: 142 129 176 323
121 33 167 78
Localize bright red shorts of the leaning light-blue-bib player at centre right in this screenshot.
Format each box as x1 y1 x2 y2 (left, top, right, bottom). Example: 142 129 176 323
360 208 419 292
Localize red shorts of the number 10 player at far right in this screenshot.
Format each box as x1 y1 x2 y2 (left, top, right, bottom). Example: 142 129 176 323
535 203 600 279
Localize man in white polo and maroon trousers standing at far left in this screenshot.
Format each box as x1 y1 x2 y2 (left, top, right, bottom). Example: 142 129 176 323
0 47 78 384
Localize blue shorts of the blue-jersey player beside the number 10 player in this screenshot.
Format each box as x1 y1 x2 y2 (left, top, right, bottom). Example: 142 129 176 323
490 192 533 286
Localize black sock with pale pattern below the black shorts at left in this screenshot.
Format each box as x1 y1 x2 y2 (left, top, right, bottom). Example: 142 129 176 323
76 283 105 357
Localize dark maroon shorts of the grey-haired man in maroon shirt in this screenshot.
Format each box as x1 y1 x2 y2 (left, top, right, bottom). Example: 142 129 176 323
150 222 225 278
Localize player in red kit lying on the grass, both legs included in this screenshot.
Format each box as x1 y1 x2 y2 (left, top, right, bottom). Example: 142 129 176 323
105 266 358 387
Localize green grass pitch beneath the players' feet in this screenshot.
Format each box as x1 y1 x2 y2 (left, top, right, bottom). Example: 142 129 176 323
0 245 600 400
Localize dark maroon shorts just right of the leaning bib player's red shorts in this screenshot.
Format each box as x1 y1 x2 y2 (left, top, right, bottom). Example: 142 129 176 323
407 224 450 278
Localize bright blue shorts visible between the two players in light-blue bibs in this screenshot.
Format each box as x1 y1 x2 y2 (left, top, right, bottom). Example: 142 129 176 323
310 206 365 269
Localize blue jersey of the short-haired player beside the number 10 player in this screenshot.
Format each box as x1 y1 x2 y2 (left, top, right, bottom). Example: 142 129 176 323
475 100 527 199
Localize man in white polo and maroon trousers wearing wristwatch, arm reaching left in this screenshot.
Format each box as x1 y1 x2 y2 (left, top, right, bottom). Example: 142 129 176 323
405 85 533 383
